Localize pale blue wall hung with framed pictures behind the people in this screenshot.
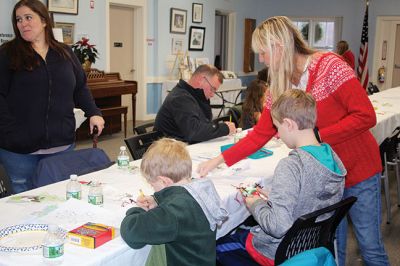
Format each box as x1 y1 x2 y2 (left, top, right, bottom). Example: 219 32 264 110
0 0 400 113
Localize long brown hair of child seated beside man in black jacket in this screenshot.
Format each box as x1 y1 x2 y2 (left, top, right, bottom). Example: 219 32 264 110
241 79 268 128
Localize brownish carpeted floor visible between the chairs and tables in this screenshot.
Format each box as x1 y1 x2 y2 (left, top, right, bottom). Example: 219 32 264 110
76 121 400 266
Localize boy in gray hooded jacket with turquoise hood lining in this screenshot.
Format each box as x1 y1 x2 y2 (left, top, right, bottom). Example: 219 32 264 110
217 89 347 265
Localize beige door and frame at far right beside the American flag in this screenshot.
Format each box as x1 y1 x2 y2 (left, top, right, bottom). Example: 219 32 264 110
370 16 400 90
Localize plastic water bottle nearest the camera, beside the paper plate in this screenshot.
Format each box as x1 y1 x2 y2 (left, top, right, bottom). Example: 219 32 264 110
42 224 64 260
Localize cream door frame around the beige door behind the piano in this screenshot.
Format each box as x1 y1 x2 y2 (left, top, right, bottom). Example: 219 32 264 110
105 0 147 120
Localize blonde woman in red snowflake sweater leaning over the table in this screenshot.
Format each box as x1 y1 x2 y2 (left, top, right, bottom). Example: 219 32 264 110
198 17 388 265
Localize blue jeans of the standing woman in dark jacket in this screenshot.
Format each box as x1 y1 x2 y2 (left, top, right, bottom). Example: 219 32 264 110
0 145 75 194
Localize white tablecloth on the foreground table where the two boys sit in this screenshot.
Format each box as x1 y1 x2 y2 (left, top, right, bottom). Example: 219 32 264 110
0 132 289 265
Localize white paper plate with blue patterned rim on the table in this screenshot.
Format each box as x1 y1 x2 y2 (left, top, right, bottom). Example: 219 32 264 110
0 224 67 252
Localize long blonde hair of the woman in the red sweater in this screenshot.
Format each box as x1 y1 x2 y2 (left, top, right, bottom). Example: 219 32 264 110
252 16 315 102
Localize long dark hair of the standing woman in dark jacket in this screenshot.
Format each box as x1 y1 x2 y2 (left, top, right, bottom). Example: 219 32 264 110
1 0 72 71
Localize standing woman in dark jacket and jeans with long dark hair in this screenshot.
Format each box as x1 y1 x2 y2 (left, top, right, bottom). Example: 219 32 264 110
0 0 104 193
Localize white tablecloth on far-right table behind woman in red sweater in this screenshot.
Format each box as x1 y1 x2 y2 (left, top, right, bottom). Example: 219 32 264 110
369 87 400 144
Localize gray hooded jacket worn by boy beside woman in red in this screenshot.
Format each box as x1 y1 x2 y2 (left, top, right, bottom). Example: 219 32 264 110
250 149 347 259
